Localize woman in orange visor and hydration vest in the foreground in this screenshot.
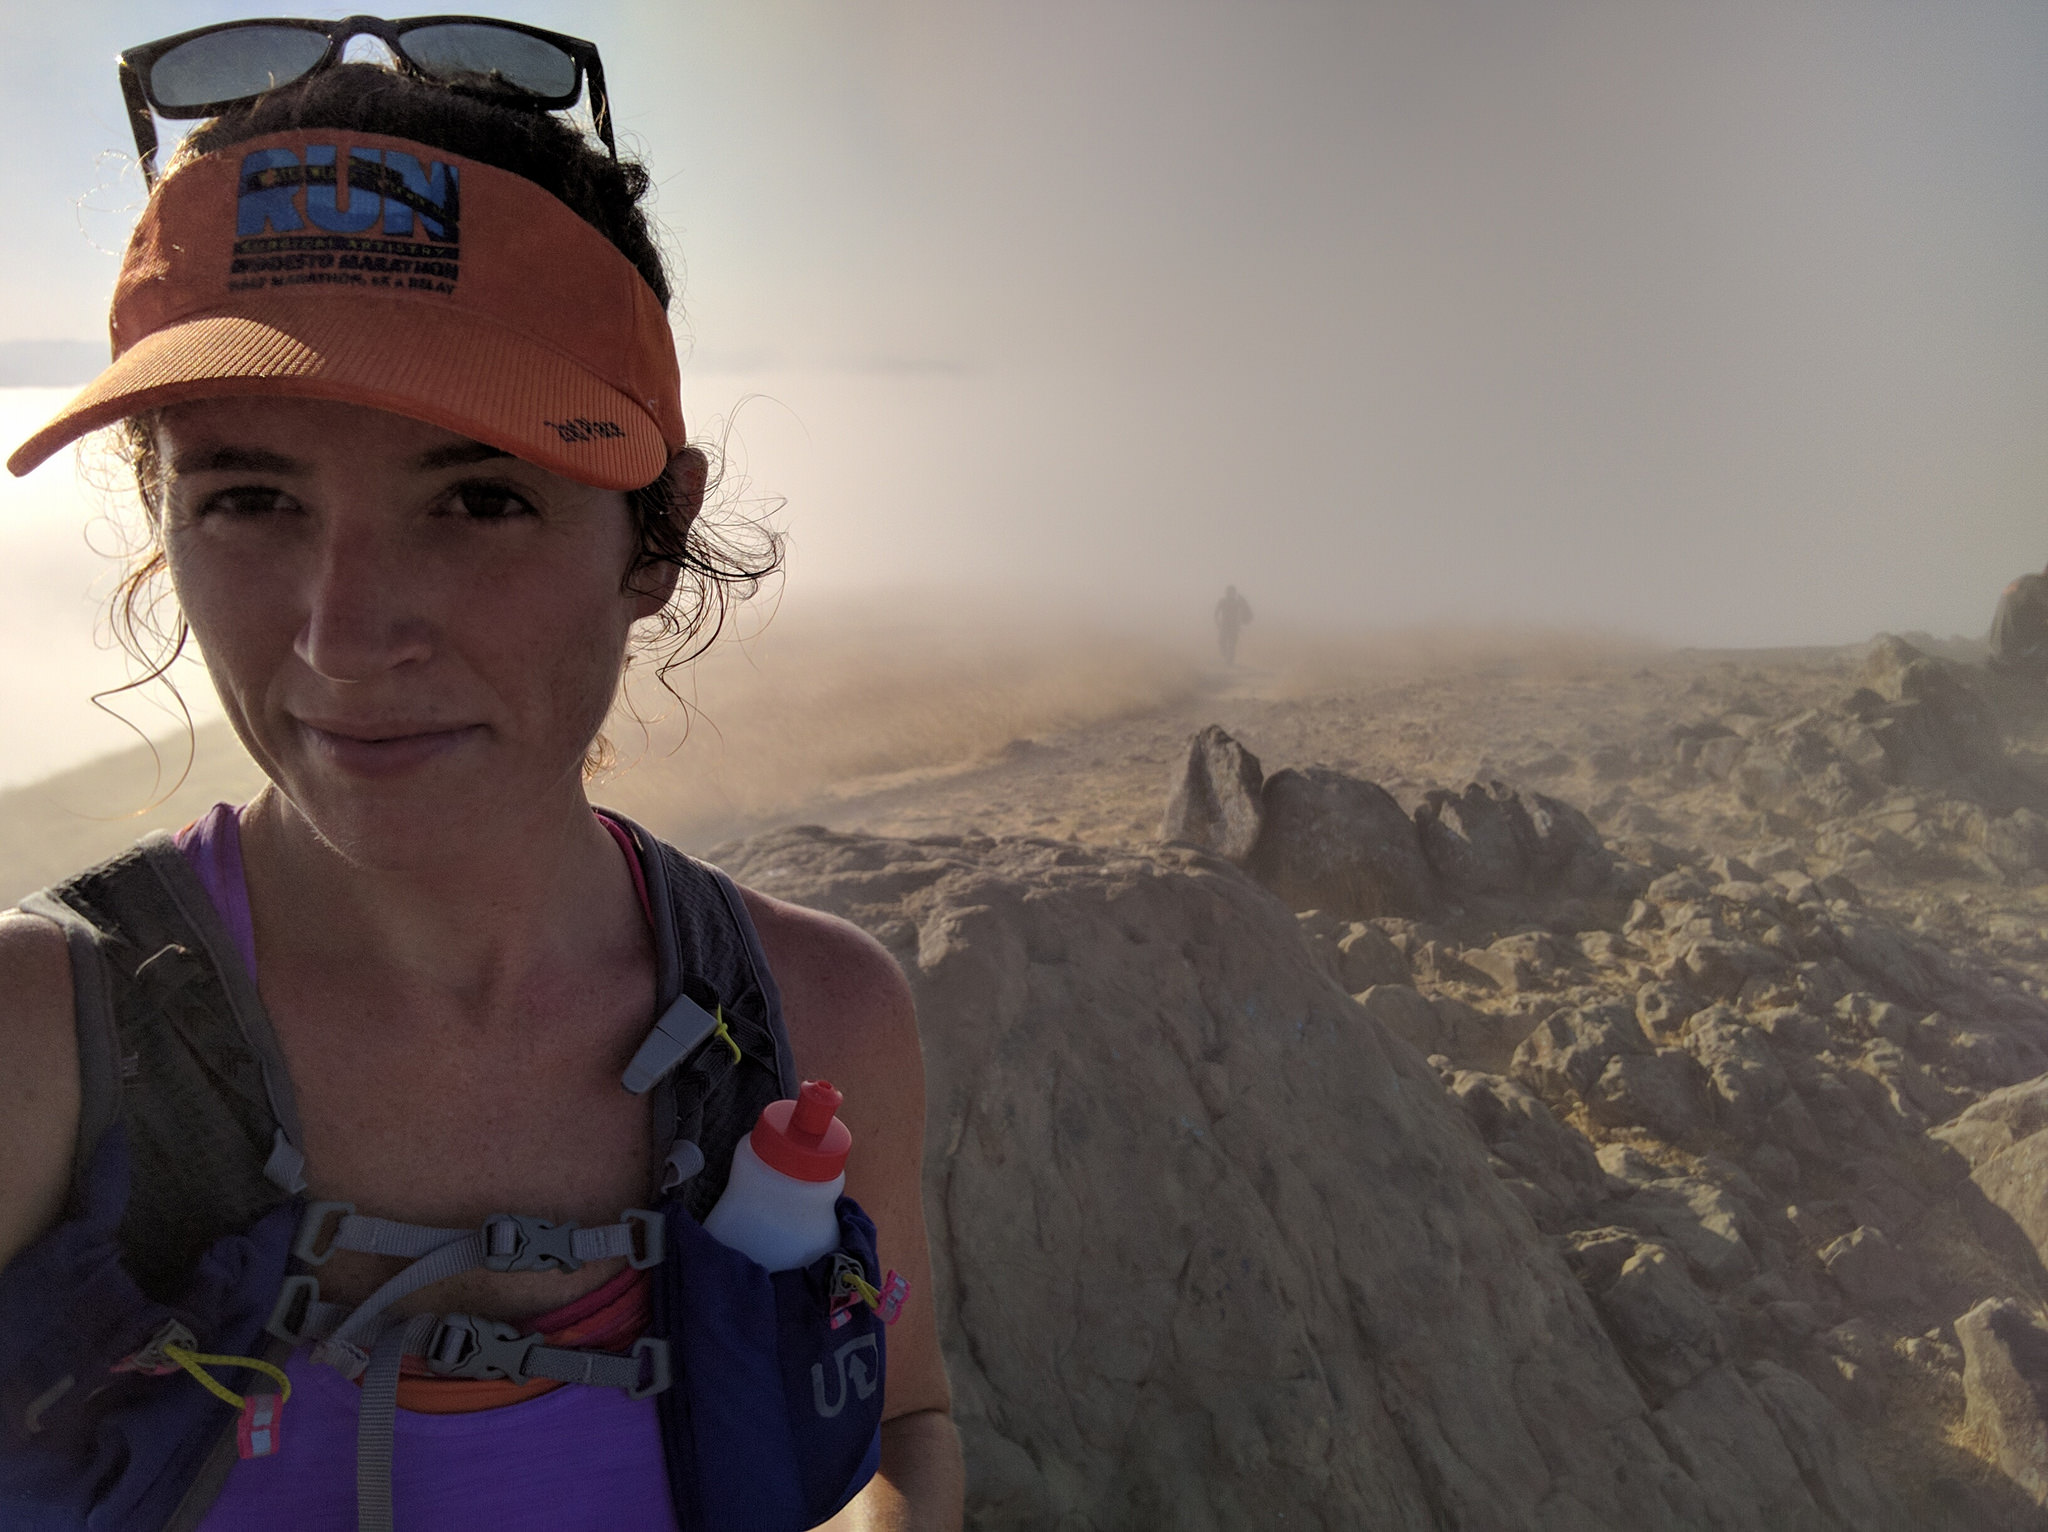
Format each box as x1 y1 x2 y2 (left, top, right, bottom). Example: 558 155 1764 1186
0 18 961 1530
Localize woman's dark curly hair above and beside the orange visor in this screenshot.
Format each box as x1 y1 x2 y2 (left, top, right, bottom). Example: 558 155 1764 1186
99 63 782 768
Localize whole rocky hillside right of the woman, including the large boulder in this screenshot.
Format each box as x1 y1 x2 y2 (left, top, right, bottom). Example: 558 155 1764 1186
696 639 2048 1530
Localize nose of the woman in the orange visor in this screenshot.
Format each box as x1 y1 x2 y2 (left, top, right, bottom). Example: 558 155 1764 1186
293 530 432 682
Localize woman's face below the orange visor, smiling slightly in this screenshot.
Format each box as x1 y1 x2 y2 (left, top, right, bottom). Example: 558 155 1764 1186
158 399 666 866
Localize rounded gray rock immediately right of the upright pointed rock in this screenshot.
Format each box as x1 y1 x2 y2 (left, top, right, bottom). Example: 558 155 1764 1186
1245 766 1438 920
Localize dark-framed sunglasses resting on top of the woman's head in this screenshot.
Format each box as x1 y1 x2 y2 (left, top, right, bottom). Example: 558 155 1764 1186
121 16 618 184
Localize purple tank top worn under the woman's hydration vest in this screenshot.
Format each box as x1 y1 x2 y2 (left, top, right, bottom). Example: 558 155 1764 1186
178 803 676 1532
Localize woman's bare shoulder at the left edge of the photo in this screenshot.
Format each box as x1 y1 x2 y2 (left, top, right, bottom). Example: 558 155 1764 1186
0 909 78 1266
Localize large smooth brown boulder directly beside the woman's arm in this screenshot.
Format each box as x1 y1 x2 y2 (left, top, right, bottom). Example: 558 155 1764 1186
721 819 1875 1532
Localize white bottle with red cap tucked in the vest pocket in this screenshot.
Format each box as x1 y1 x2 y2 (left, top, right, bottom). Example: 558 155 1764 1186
705 1079 854 1272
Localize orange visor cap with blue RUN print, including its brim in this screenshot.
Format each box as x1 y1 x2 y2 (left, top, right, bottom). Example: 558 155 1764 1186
8 129 684 490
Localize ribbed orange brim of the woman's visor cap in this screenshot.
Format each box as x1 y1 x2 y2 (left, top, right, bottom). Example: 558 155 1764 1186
6 297 670 490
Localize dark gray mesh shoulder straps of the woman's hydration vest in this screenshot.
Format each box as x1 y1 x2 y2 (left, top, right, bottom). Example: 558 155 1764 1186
20 815 799 1532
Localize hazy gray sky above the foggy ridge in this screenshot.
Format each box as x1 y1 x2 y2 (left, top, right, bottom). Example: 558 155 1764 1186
0 0 2048 770
